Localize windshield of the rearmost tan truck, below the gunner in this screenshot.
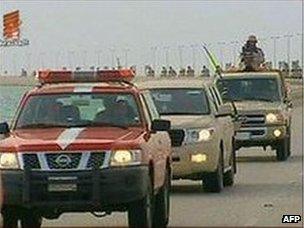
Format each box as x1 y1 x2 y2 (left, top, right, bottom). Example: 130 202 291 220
218 76 281 102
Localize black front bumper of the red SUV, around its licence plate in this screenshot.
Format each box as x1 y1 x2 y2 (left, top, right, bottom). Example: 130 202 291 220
1 166 150 213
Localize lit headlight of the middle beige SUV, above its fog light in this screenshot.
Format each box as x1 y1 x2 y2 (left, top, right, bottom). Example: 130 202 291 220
185 128 214 143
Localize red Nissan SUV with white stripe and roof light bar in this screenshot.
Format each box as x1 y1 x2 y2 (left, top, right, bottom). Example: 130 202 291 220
0 70 172 227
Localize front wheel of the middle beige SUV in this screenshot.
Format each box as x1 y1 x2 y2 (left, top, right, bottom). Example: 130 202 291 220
203 153 224 192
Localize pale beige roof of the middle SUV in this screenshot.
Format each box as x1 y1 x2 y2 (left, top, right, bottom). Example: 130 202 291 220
136 78 213 89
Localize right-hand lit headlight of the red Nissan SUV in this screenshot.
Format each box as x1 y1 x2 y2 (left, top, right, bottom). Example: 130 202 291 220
111 150 141 166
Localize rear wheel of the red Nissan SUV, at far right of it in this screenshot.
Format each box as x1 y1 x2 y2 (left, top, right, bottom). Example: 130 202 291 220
153 169 171 227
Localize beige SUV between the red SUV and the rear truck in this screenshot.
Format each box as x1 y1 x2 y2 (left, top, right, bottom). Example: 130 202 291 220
138 79 236 192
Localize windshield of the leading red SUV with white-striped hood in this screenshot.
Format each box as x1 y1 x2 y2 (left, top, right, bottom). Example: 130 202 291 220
16 93 140 128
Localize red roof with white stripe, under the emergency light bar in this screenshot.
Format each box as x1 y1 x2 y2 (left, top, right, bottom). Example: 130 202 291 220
29 82 138 94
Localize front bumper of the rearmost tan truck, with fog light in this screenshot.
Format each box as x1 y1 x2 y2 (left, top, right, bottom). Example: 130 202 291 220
235 125 287 149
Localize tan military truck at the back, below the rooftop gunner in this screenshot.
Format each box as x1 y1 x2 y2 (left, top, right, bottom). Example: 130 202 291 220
216 70 292 161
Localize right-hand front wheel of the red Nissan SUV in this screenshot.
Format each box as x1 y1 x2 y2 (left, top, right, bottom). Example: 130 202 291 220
128 178 153 228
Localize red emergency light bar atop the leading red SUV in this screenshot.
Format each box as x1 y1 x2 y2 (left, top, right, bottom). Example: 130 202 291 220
38 69 135 84
